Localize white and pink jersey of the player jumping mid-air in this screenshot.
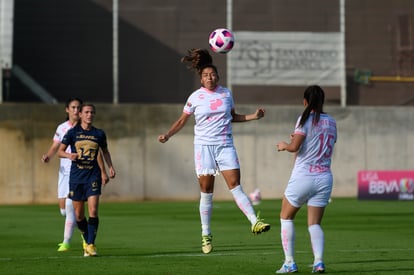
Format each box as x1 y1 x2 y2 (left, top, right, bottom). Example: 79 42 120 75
183 86 234 145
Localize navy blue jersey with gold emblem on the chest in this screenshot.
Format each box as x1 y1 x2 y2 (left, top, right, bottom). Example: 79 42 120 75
62 124 108 183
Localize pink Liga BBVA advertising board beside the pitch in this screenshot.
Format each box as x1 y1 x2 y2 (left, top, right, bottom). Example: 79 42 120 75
358 170 414 200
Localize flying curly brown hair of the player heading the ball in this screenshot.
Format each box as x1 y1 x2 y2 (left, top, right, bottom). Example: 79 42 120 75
181 49 218 76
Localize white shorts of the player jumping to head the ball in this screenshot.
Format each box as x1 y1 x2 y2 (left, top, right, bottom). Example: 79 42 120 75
194 144 240 176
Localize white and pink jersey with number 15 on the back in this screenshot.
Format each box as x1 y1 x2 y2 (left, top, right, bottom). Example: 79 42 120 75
292 113 337 177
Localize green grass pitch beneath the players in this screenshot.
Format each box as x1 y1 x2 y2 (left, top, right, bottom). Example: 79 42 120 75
0 199 414 275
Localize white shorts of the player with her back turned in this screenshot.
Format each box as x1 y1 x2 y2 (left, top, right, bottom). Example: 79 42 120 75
285 174 333 208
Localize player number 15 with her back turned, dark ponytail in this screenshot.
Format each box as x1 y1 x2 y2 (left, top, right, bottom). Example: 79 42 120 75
276 85 337 273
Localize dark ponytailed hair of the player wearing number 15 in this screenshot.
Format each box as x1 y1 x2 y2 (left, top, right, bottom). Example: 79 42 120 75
299 85 325 127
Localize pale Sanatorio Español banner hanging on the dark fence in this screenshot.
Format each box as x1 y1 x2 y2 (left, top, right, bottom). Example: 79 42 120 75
229 31 344 86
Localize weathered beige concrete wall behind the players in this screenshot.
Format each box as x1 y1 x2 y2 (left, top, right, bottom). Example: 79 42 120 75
0 104 414 204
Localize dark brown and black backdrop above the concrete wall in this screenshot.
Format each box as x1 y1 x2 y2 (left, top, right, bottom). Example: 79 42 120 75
3 0 414 105
